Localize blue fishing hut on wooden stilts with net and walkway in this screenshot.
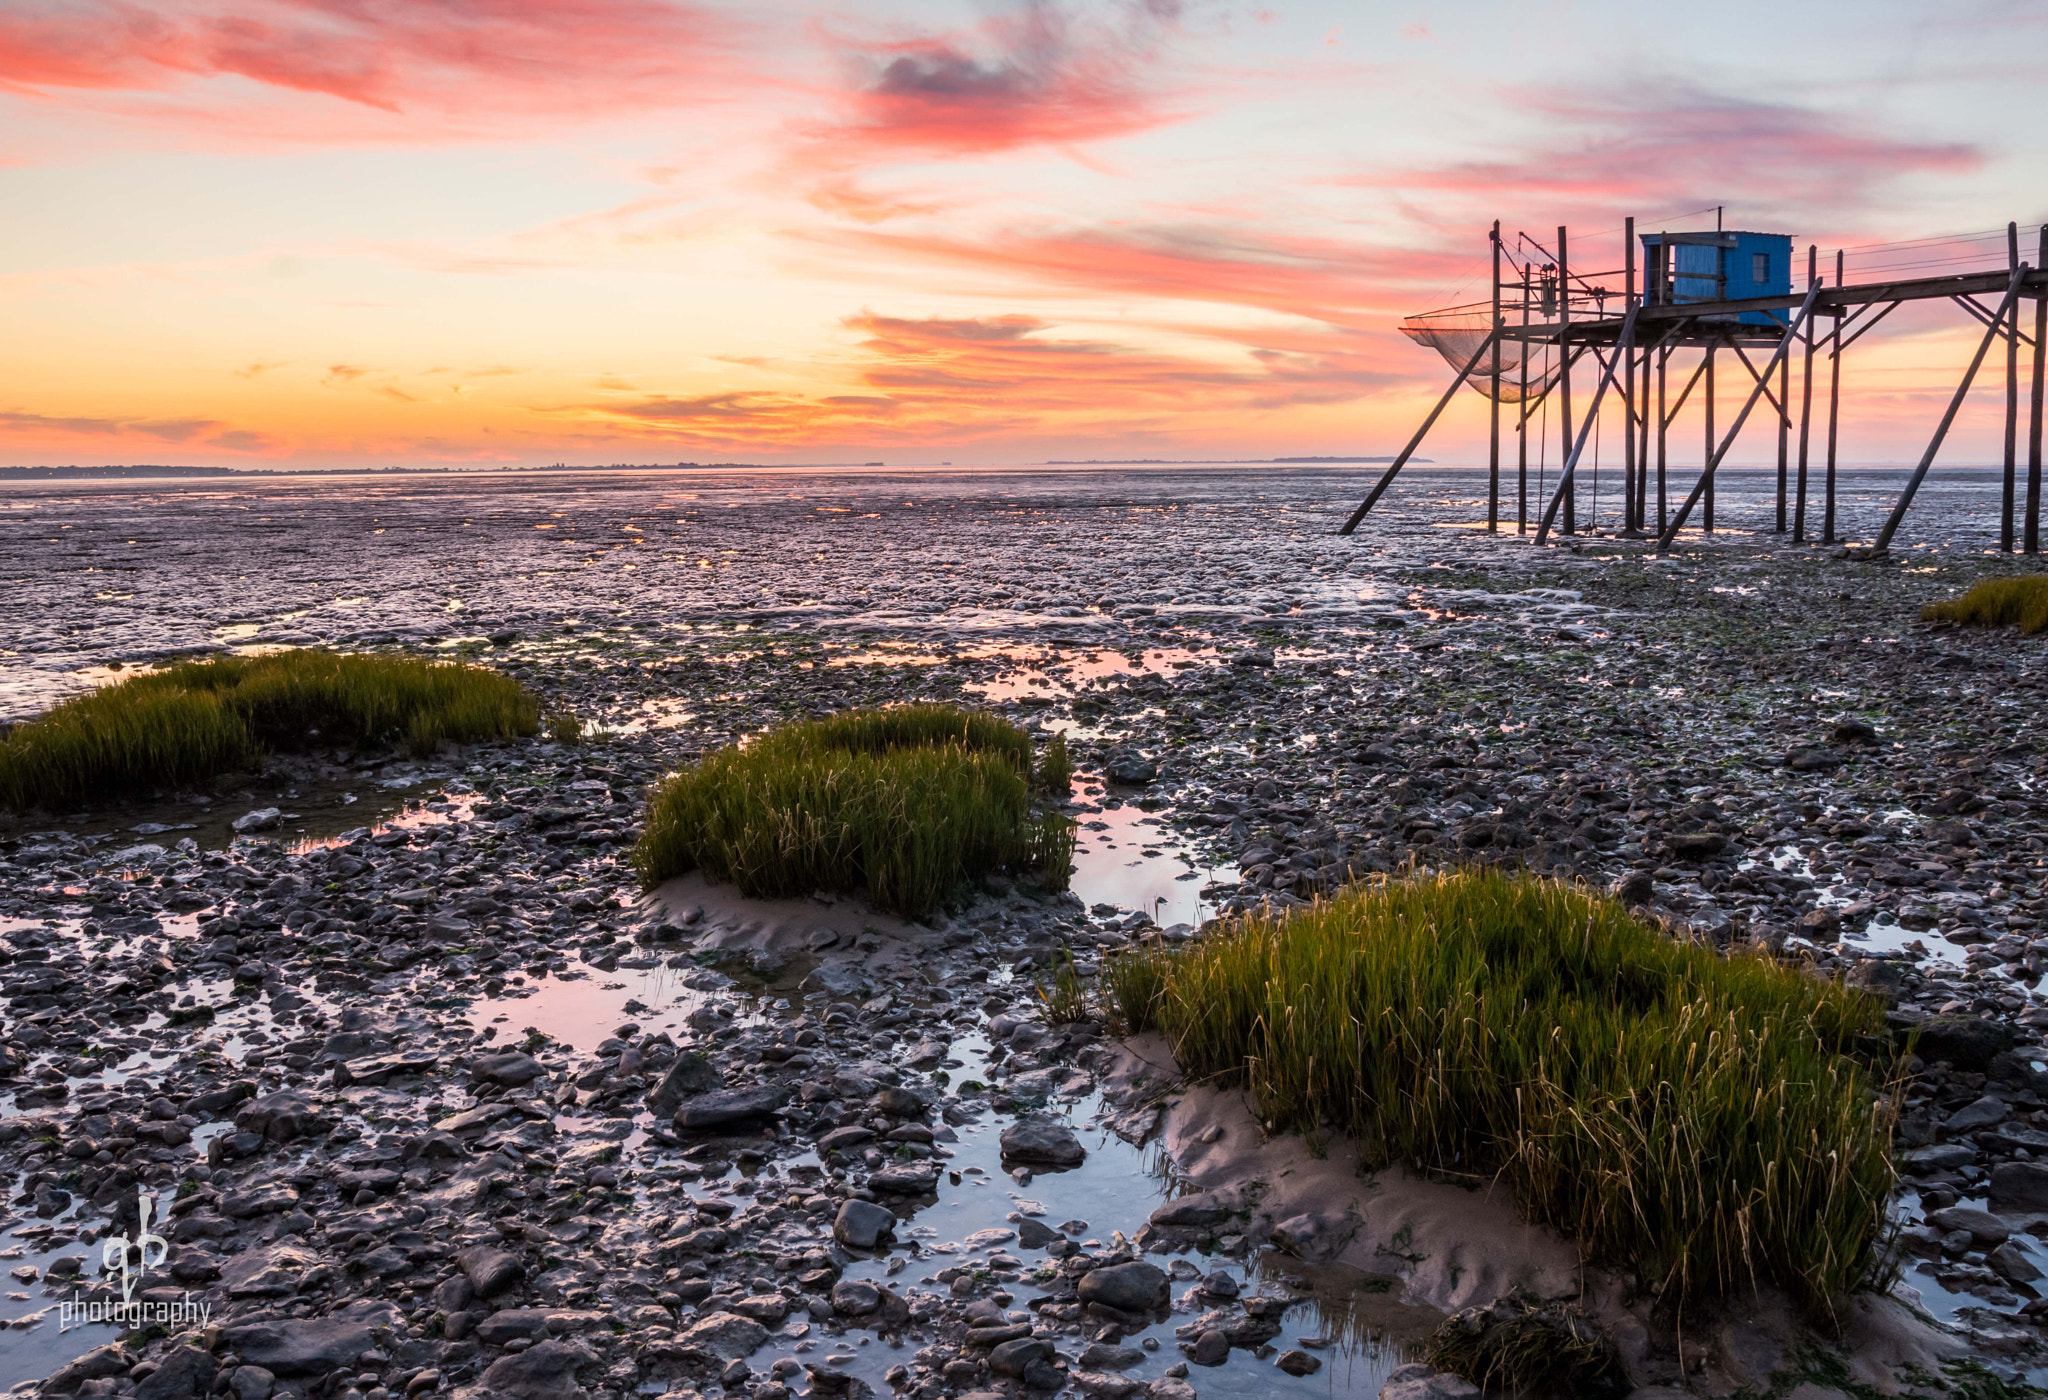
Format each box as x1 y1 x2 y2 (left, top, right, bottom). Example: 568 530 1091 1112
1337 217 2048 555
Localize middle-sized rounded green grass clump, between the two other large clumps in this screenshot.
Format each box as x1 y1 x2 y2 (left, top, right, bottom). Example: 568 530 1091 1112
633 704 1073 917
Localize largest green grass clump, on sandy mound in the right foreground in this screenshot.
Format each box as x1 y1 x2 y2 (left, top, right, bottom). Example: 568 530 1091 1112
1102 872 1898 1316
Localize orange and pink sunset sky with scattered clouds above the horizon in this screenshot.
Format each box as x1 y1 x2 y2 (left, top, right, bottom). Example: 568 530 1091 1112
0 0 2048 467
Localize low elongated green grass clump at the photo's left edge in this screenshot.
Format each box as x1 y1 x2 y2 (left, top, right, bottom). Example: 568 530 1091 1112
0 651 541 808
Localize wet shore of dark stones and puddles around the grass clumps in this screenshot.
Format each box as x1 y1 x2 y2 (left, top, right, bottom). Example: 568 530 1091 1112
0 464 2048 1400
